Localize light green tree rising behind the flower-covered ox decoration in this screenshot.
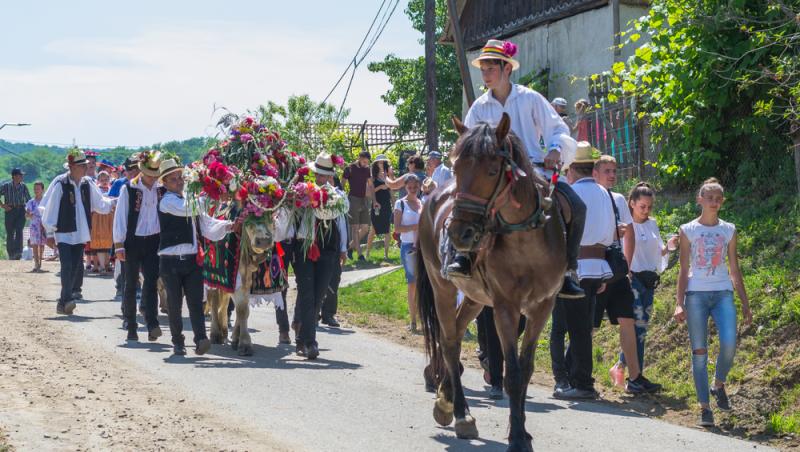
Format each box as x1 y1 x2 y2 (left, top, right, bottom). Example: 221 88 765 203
259 94 350 159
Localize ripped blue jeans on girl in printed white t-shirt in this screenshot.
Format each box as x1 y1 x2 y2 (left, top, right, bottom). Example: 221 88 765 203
686 290 736 404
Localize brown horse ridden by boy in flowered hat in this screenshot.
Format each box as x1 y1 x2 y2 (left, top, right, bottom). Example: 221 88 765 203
417 114 568 451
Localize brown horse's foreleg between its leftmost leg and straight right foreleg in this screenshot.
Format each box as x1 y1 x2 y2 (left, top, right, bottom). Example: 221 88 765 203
443 298 483 439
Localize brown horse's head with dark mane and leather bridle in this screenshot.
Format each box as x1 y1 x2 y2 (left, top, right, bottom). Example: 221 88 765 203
447 113 532 252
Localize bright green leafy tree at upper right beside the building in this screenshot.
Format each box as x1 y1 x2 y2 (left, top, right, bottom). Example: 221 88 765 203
607 0 800 193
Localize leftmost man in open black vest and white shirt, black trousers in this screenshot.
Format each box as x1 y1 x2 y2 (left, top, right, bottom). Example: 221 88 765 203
40 149 116 315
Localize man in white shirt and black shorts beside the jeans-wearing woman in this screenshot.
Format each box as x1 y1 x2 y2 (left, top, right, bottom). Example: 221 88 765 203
592 155 661 394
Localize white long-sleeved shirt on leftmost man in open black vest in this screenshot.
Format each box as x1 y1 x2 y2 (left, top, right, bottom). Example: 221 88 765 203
39 173 116 245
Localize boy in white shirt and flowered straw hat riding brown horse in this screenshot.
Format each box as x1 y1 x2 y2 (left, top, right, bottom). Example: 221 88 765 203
447 39 586 299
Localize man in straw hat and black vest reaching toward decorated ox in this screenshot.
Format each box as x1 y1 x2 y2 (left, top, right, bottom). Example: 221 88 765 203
158 157 234 356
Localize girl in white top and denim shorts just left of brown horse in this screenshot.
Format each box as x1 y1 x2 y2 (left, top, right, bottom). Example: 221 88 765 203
394 173 422 332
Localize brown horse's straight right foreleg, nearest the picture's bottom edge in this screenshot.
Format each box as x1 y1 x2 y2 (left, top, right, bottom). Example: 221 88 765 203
494 300 532 452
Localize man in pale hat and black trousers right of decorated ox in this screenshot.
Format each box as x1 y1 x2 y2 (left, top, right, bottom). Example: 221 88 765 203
288 152 347 360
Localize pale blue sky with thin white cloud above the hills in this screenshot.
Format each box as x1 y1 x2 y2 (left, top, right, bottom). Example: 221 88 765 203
0 0 424 147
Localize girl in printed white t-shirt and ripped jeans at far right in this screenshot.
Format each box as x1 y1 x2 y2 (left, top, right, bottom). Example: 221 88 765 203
674 178 753 427
